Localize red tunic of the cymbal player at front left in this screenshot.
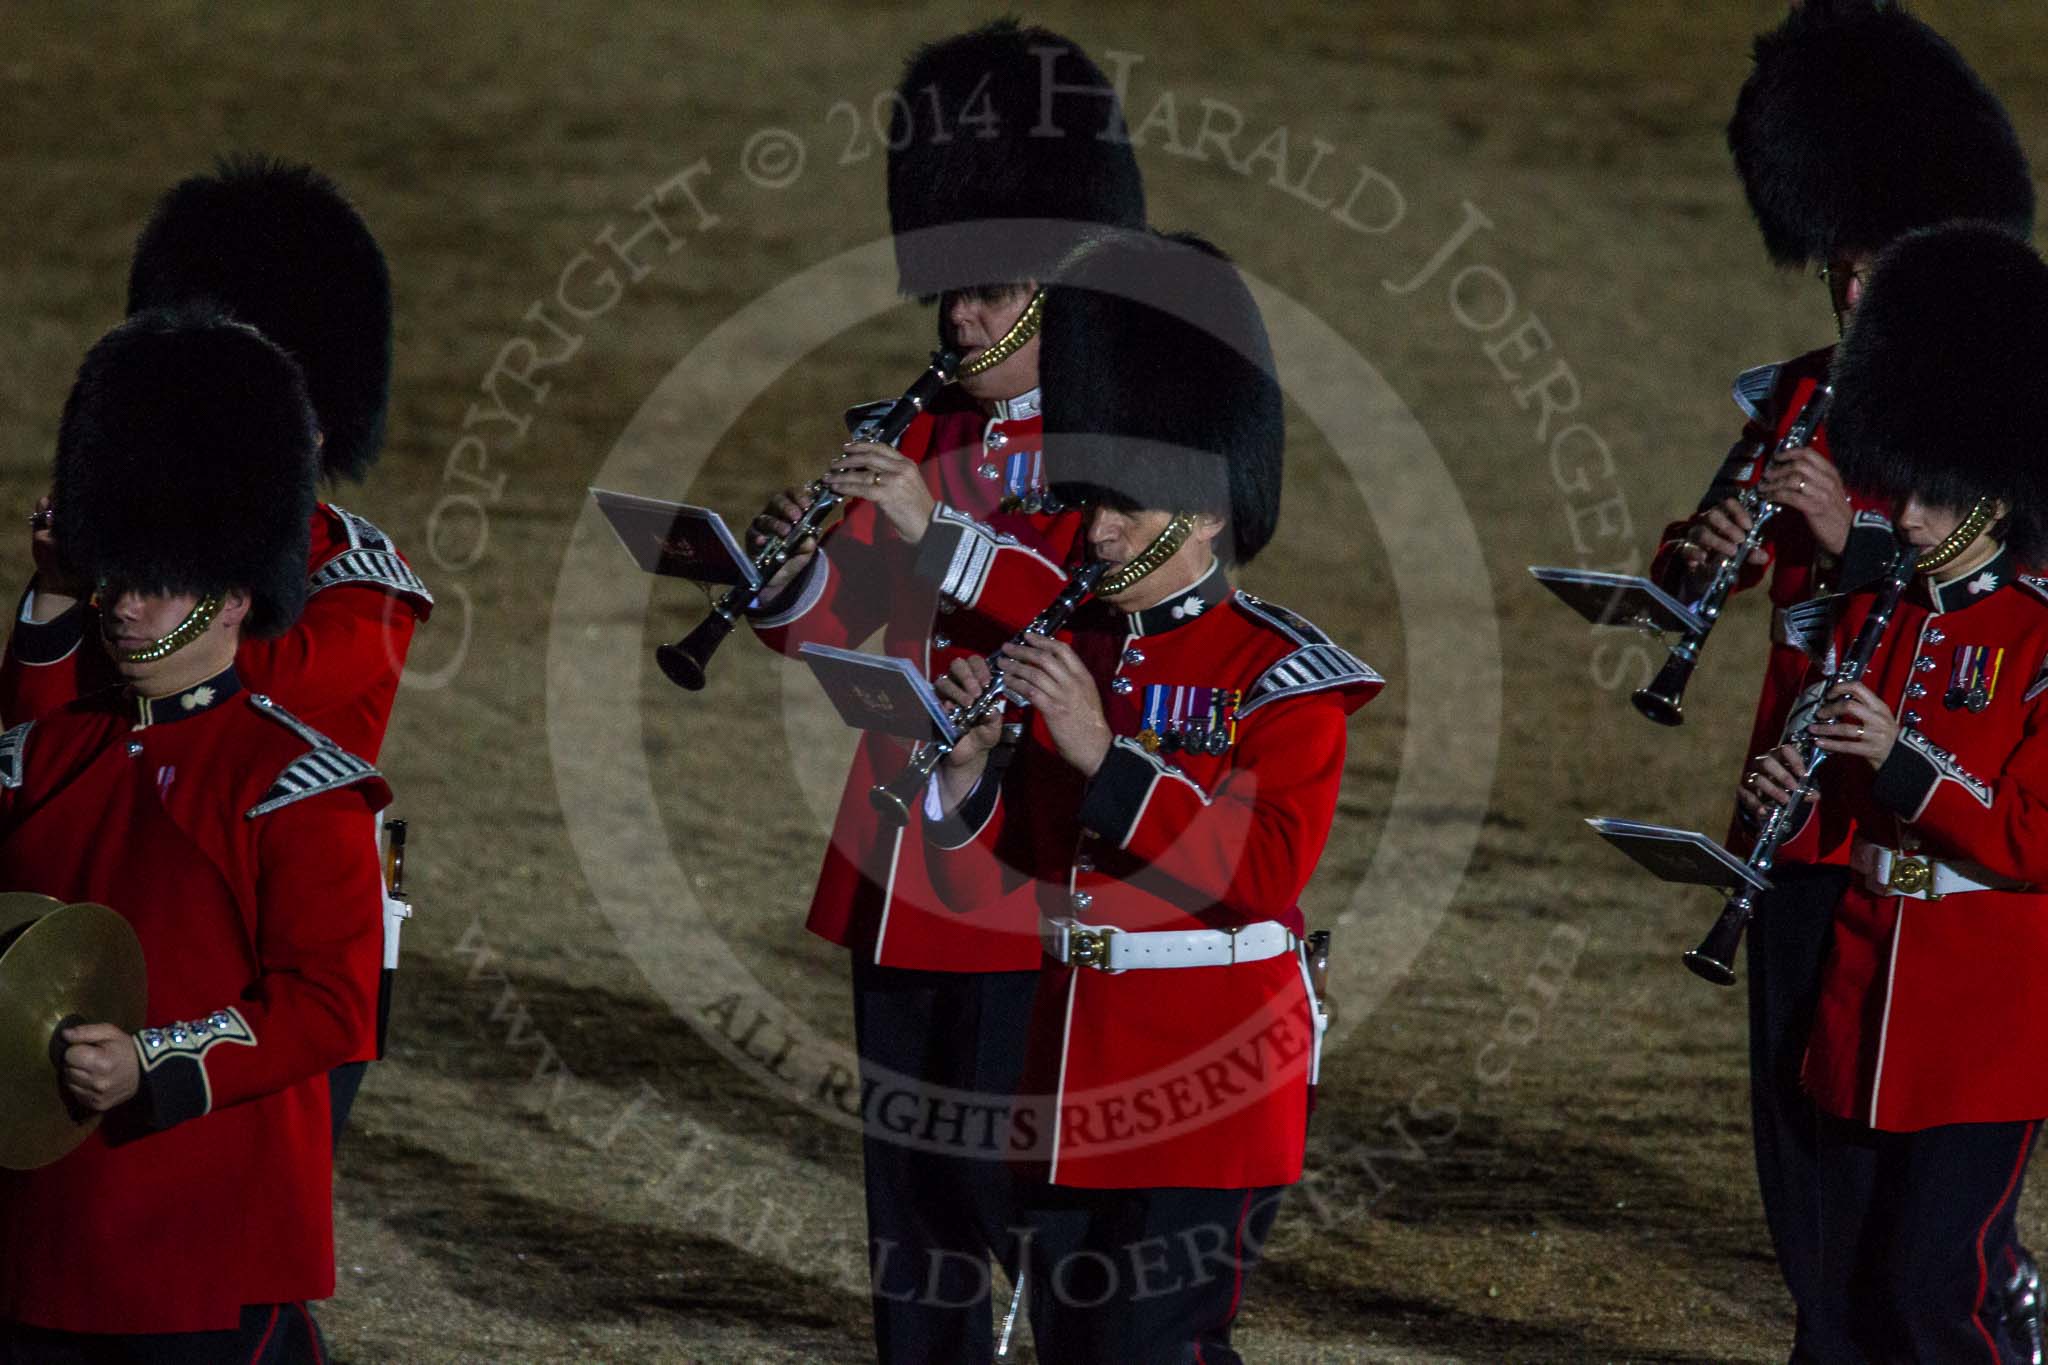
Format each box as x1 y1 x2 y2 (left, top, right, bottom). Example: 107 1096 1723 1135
0 671 389 1332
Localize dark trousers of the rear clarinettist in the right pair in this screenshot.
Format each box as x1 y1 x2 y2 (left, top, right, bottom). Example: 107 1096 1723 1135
1747 866 1849 1359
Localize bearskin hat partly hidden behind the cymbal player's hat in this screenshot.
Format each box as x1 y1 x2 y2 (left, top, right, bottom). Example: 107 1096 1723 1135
129 158 391 481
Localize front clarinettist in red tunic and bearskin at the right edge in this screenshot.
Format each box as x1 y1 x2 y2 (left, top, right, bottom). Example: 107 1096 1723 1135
1743 225 2048 1363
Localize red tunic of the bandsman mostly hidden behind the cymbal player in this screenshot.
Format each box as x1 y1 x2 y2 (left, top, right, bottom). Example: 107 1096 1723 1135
0 503 434 763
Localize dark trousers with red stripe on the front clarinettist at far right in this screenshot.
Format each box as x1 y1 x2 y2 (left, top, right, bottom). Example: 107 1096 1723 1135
1810 1117 2040 1365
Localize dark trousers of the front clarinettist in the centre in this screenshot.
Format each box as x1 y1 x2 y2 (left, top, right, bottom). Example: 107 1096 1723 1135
1026 1185 1286 1365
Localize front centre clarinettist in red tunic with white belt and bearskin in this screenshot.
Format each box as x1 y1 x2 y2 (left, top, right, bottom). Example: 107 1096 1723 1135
926 237 1382 1365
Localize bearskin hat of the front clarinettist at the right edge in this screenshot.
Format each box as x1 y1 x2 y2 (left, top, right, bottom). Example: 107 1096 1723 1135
1827 223 2048 563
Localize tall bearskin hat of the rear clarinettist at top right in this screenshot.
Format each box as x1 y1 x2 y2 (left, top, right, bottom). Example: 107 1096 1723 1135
1729 0 2034 266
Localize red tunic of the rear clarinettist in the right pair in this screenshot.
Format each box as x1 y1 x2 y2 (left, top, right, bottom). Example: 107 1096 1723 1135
1651 346 1892 834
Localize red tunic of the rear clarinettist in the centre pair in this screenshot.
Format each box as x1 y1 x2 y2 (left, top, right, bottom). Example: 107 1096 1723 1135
754 391 1081 972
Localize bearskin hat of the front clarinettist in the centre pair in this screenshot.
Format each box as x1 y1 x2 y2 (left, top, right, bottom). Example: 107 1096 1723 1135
1038 233 1286 563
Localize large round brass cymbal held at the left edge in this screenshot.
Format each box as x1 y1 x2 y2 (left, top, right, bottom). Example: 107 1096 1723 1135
0 896 147 1171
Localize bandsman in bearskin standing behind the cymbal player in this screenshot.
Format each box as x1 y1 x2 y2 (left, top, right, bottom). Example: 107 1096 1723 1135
0 160 434 1134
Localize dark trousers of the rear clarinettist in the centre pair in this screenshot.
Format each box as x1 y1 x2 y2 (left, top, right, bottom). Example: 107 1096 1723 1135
854 952 1038 1365
